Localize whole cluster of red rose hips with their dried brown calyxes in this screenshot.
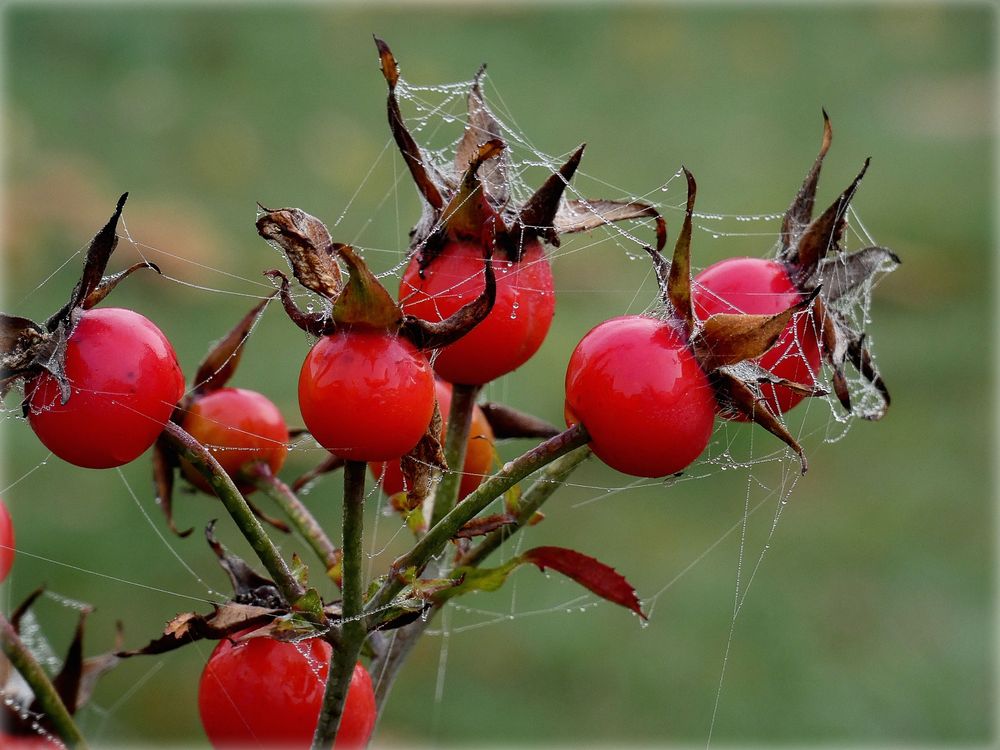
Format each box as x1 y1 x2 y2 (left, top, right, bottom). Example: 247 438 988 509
0 42 896 747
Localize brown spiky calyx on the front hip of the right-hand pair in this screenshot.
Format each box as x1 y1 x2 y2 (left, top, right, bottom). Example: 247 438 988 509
647 168 826 473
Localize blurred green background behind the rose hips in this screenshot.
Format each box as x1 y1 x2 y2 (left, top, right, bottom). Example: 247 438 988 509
0 3 997 746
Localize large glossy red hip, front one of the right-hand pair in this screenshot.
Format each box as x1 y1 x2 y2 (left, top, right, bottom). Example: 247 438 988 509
566 316 715 477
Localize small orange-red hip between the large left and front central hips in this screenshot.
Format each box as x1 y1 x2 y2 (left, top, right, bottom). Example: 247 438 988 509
181 388 288 494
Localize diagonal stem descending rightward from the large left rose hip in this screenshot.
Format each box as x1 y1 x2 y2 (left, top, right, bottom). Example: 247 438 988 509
163 422 305 604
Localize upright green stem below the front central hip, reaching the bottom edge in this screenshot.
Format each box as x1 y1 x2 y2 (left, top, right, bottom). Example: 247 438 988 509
312 461 368 750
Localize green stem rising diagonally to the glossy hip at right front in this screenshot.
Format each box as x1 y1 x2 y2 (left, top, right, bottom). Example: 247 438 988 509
365 425 590 617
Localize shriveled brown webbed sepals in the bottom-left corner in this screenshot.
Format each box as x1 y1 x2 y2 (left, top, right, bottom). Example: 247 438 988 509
0 587 122 737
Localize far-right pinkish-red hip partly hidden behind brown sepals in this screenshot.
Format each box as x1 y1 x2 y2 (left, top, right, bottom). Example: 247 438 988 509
691 258 820 419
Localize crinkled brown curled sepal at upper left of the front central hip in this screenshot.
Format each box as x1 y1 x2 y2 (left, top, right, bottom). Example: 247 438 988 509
257 206 341 299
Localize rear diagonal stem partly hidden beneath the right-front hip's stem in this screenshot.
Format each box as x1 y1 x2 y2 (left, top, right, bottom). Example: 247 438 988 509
371 447 593 709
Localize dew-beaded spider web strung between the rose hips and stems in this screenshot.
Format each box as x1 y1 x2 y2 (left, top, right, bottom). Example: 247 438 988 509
0 66 889 744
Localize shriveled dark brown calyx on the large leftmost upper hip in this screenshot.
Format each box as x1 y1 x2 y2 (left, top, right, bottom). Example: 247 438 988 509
0 193 160 404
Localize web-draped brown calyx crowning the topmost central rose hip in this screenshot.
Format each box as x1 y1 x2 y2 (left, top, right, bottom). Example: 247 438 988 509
375 38 666 273
